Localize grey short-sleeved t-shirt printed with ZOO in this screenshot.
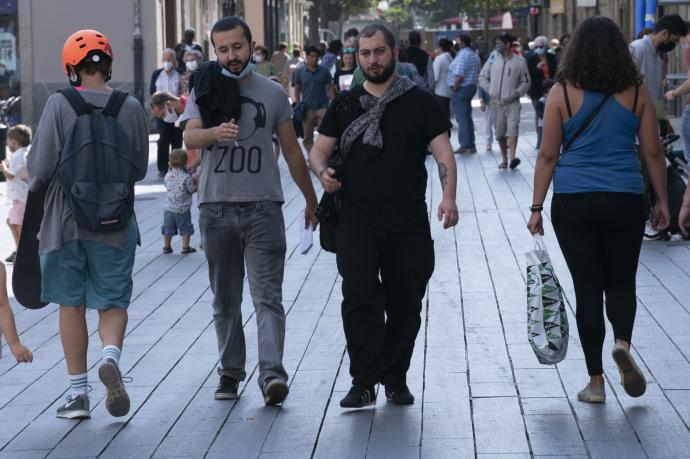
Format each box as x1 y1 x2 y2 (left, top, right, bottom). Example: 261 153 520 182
180 73 292 204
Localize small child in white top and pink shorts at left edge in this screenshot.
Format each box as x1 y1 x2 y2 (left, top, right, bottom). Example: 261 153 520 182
0 124 31 263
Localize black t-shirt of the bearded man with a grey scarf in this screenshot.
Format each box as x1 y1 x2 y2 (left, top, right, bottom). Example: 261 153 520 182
319 85 451 232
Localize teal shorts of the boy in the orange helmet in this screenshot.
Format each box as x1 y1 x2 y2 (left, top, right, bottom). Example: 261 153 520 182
40 218 137 309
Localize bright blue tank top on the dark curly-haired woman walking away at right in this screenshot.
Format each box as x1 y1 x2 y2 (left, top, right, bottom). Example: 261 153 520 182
553 91 644 194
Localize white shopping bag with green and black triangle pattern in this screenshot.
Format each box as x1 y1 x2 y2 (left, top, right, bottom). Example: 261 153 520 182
526 235 568 365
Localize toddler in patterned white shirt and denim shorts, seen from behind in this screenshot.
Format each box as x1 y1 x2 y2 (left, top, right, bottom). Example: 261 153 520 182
161 149 196 253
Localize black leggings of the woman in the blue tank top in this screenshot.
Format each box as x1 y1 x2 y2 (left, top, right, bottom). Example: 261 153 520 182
551 193 645 375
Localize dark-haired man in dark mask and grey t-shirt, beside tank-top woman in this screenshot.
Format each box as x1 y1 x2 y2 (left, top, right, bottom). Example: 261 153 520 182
630 14 688 117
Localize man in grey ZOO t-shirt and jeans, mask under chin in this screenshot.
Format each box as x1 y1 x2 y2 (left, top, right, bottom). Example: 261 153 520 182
180 17 317 405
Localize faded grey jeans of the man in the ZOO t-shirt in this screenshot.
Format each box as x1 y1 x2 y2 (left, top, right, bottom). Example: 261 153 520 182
199 201 287 385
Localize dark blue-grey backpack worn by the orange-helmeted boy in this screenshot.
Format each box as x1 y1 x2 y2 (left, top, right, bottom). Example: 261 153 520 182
56 88 136 232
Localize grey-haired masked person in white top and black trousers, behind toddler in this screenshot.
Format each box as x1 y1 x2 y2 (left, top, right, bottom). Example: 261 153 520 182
149 48 182 178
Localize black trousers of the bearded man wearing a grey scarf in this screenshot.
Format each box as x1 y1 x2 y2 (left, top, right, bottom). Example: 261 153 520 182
335 218 434 386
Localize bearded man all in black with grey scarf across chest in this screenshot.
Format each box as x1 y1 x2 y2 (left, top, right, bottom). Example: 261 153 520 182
309 24 458 408
